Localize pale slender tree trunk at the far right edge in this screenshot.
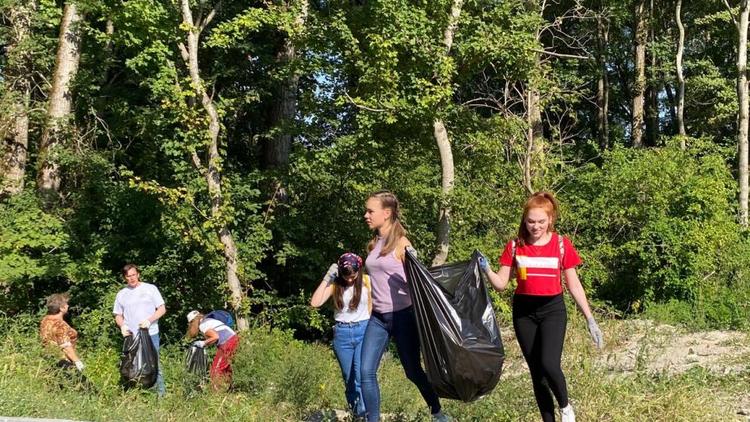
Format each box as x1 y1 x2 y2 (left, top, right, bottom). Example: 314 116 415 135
736 0 750 228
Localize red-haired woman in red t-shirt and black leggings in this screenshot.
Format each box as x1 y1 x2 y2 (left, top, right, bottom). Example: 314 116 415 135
479 192 604 422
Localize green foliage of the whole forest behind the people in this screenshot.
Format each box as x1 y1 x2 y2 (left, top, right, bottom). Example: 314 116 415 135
0 0 750 344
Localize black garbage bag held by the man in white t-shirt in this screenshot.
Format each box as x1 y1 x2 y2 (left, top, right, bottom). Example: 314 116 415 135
120 328 159 388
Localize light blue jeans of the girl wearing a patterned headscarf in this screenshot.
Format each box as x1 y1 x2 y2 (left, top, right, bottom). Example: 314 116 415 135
333 320 367 416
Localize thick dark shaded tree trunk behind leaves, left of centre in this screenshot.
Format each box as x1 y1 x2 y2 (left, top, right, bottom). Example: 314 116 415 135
263 0 308 169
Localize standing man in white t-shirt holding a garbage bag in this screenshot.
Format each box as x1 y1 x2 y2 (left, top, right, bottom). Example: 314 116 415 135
112 264 167 397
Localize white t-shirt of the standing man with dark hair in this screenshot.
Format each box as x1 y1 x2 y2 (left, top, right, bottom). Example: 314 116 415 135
112 282 164 335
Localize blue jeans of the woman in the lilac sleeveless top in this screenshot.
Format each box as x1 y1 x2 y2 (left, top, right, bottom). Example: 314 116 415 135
362 306 440 422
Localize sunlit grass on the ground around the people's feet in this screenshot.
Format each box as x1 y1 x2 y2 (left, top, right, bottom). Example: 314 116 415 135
0 316 750 421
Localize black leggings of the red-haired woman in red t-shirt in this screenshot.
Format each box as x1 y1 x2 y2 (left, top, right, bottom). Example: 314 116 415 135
513 294 568 422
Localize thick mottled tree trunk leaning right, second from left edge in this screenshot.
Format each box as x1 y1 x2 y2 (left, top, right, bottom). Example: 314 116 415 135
37 1 81 202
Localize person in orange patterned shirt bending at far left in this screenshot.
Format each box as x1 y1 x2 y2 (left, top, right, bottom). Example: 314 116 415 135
39 293 86 380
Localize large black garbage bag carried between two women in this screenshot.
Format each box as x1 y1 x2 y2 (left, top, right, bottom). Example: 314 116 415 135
404 251 505 402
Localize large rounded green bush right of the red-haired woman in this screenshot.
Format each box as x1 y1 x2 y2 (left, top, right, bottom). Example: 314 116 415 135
561 143 750 327
